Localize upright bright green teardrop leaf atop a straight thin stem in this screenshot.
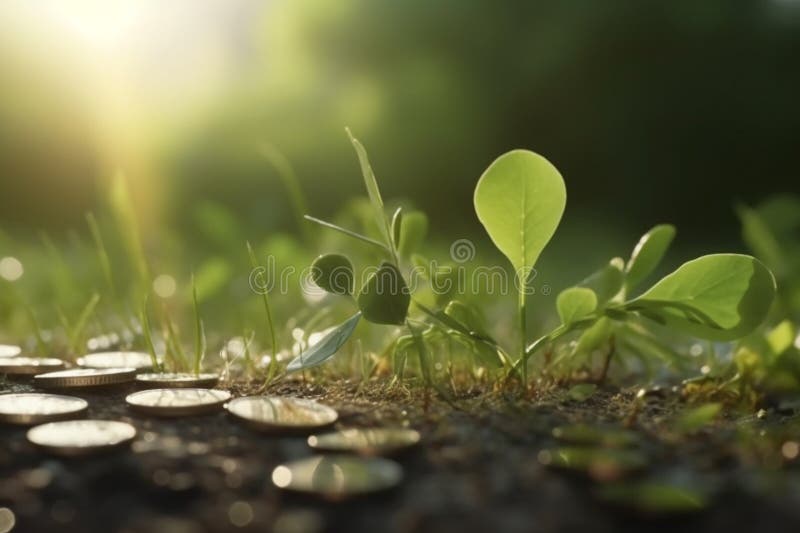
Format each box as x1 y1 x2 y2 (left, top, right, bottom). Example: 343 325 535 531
474 150 567 278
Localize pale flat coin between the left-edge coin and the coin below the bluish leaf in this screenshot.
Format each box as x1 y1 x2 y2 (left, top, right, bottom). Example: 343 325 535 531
125 389 231 416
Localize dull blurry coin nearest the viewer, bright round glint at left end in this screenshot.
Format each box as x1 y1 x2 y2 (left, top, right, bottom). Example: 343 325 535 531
272 455 403 500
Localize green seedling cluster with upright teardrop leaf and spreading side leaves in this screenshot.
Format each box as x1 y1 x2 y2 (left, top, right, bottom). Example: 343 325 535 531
289 141 776 390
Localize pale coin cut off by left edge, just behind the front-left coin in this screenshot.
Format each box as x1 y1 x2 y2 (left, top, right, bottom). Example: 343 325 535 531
0 392 89 425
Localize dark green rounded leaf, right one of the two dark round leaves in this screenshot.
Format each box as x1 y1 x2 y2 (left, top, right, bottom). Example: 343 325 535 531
358 262 411 324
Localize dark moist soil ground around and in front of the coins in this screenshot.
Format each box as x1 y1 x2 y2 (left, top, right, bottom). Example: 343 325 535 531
0 376 800 533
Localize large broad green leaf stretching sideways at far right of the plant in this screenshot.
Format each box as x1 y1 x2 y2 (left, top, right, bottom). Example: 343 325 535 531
623 254 775 340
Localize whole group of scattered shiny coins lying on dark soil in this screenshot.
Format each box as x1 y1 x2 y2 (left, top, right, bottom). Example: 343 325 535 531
0 345 420 490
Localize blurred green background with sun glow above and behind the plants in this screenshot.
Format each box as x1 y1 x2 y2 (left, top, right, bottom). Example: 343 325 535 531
0 0 800 340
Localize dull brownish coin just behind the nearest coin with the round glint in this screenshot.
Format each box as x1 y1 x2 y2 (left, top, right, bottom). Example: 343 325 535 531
308 428 420 455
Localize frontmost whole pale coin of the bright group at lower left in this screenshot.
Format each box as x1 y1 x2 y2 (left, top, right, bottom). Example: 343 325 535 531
28 420 136 456
